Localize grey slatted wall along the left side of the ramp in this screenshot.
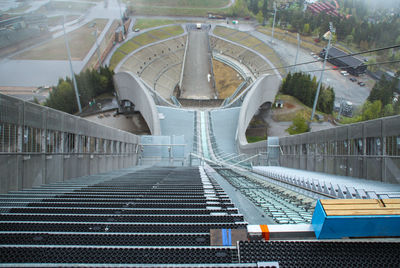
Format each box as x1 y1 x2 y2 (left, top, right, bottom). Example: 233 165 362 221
0 94 139 193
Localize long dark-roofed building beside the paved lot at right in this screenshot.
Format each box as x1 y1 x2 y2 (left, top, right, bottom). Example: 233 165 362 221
319 47 367 76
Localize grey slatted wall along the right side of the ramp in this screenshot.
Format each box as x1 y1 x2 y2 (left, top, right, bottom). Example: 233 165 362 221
279 116 400 183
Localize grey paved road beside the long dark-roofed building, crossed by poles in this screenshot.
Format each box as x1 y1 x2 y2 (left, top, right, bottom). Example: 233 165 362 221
250 31 370 105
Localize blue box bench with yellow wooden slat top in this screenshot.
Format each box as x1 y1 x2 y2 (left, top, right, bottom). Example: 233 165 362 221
312 199 400 239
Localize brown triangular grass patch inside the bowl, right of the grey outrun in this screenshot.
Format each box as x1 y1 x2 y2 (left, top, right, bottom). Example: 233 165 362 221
213 60 243 99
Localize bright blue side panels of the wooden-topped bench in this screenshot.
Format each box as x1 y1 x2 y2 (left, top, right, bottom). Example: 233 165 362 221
311 200 400 239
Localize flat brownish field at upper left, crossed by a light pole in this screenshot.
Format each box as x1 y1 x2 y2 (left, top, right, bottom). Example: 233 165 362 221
14 19 107 60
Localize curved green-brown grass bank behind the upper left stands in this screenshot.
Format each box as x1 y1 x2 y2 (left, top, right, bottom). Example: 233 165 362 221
110 25 184 69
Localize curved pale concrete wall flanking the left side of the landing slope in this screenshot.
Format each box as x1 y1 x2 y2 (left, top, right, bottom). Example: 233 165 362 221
114 72 161 135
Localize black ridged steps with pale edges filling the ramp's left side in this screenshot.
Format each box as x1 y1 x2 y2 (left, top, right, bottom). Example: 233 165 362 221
0 167 247 266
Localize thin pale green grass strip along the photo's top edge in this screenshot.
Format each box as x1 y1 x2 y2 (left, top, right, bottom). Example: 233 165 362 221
124 0 229 8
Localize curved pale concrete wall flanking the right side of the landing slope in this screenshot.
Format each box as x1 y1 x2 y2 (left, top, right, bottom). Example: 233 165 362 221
236 75 281 154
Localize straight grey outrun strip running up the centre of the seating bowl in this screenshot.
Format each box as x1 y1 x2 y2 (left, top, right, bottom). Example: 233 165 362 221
181 30 215 99
